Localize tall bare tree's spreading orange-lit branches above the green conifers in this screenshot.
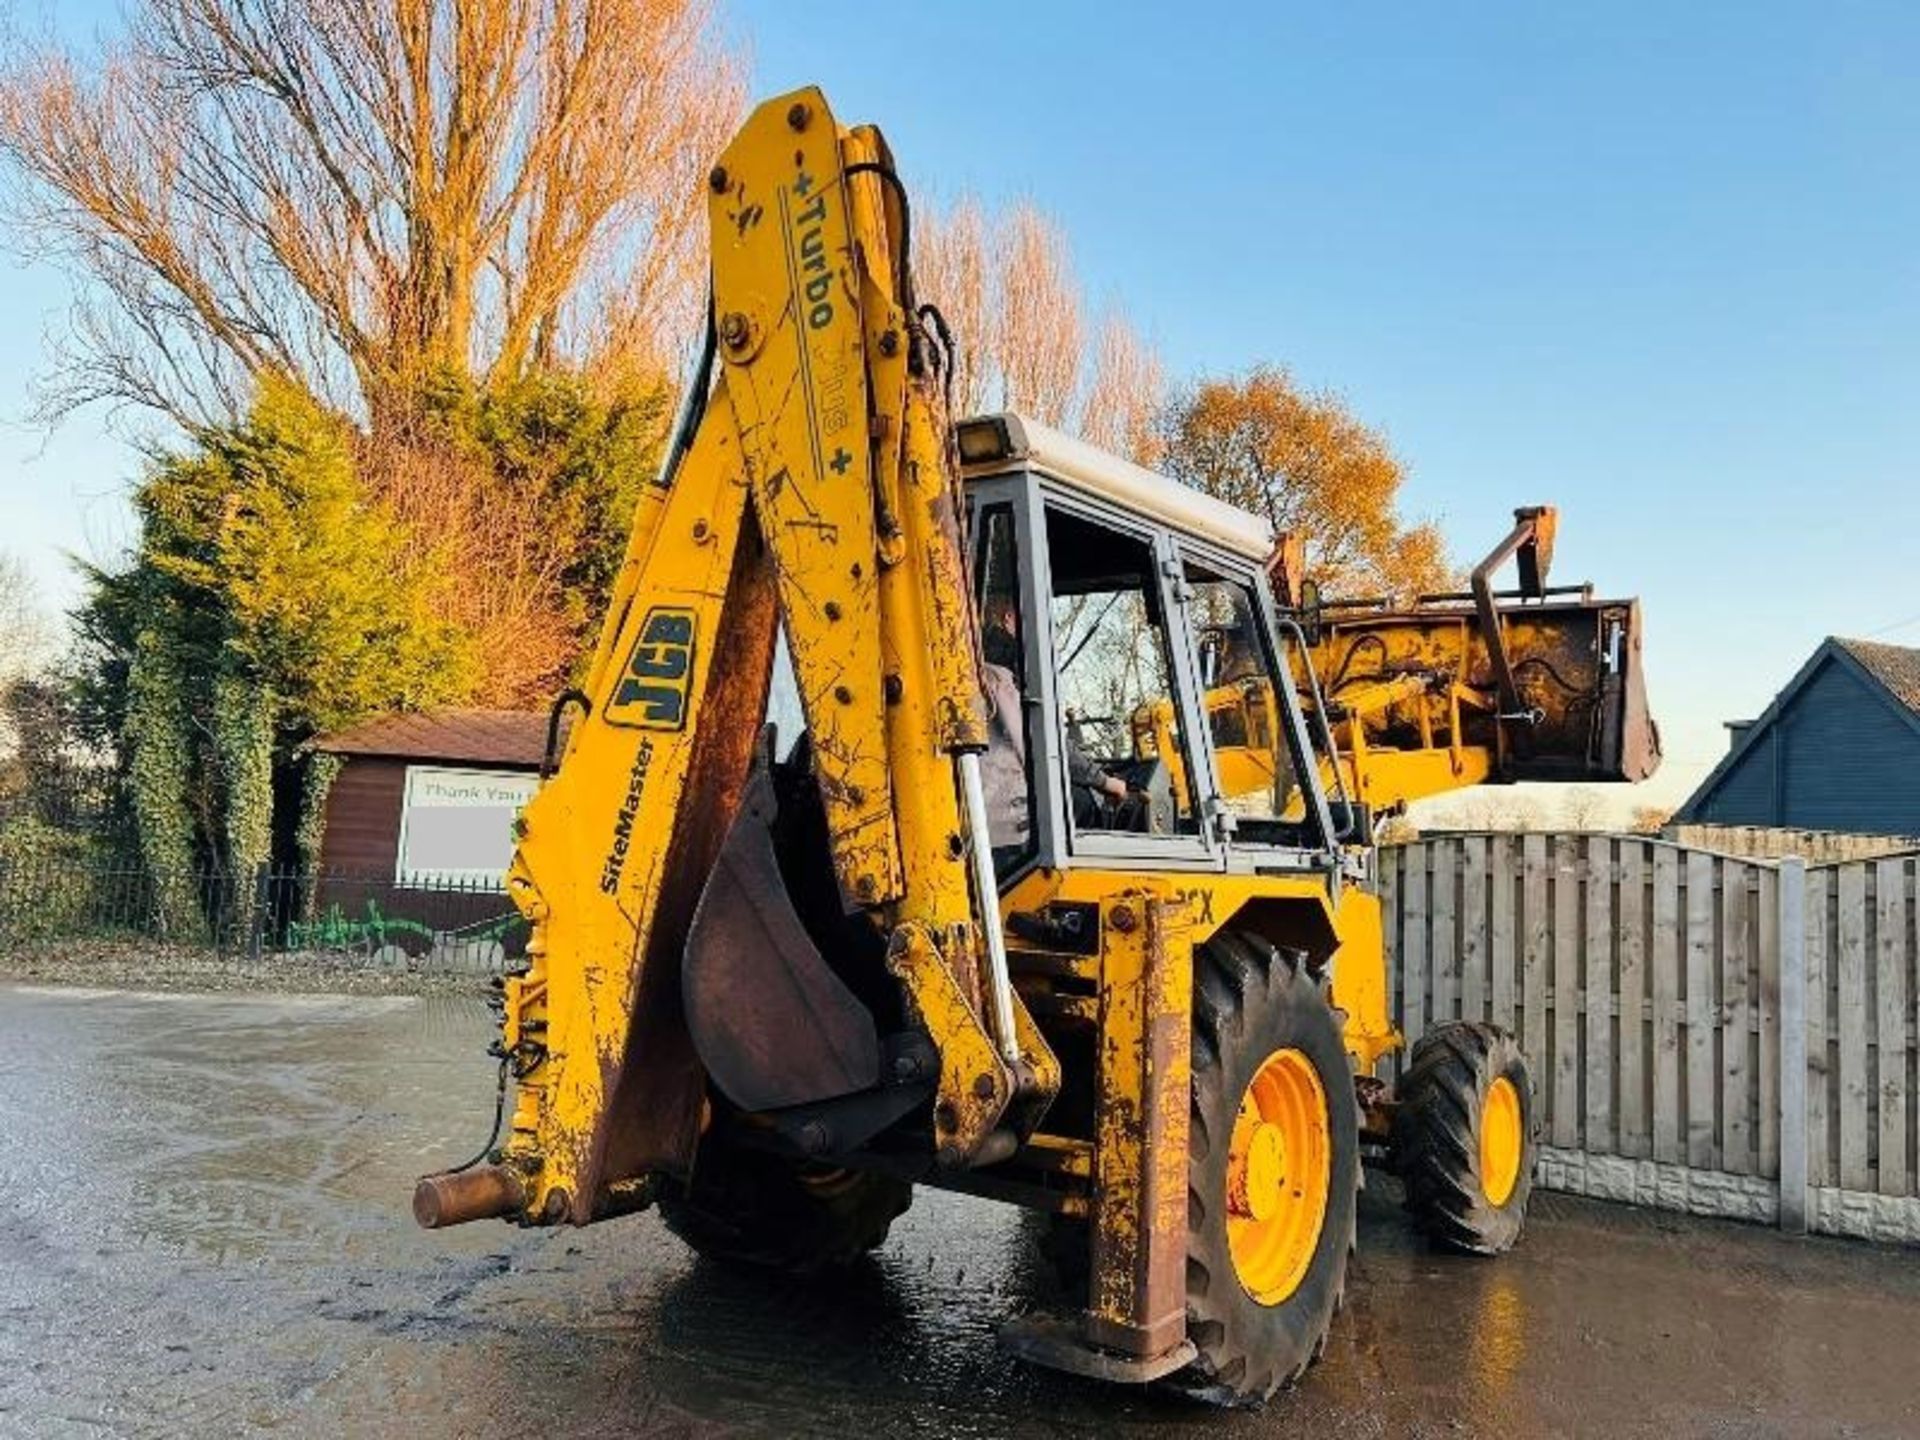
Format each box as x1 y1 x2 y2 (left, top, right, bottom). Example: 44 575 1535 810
0 0 743 424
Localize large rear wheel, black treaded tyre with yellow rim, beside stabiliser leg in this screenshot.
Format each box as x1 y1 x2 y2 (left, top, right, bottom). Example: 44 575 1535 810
1173 931 1361 1405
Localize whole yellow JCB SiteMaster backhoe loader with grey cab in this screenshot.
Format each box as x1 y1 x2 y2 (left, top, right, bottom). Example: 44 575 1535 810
415 90 1651 1402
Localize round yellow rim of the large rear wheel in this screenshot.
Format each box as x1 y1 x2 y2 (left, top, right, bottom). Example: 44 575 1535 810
1227 1050 1332 1306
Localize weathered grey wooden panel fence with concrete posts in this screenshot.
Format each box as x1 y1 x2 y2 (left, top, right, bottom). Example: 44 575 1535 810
1379 833 1920 1240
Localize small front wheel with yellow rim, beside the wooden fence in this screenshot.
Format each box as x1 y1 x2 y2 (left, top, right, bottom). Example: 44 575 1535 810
1392 1020 1534 1256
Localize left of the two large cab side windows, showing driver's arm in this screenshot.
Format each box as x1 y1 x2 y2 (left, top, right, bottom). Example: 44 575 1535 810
1046 507 1198 835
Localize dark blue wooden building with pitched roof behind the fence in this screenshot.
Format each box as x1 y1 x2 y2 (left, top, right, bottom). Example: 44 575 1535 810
1674 637 1920 835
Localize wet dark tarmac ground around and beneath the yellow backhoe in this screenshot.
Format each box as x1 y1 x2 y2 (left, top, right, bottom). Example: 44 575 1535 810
0 987 1920 1440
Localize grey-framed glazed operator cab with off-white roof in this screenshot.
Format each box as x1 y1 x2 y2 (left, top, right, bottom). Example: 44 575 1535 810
956 415 1338 885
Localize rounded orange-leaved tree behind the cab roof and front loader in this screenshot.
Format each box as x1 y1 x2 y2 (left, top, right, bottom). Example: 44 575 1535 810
1160 367 1455 599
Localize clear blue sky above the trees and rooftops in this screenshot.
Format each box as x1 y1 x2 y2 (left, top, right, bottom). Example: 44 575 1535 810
0 0 1920 814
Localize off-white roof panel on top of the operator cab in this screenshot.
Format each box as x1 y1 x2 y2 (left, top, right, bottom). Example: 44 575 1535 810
954 411 1273 561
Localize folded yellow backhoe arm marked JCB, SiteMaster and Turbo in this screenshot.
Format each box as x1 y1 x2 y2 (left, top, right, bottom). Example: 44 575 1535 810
417 90 1058 1225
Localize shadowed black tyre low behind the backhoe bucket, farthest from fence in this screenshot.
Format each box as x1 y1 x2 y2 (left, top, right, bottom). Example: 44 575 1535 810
660 1129 914 1275
